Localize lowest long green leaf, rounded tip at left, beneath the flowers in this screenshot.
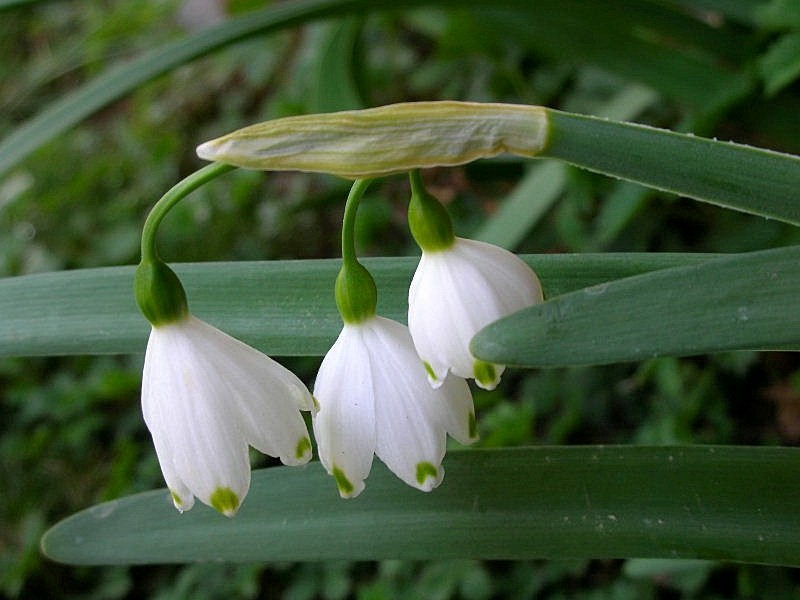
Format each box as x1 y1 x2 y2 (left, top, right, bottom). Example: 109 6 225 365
42 446 800 566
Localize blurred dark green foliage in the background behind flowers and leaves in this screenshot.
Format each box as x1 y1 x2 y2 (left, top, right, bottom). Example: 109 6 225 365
0 0 800 599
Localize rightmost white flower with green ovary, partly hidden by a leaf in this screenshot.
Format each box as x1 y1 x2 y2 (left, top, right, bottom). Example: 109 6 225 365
408 172 542 390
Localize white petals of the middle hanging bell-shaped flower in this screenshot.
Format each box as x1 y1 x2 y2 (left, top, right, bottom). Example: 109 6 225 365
312 315 476 498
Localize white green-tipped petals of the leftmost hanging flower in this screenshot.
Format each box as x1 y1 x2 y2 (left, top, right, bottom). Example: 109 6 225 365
142 313 312 516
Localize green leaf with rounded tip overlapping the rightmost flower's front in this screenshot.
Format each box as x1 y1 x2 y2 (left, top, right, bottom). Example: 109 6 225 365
472 246 800 367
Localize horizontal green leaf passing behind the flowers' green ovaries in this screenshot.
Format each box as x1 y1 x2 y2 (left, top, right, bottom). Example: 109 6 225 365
0 254 707 356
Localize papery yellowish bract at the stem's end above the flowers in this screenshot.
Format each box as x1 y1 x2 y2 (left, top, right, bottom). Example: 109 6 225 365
197 101 547 179
